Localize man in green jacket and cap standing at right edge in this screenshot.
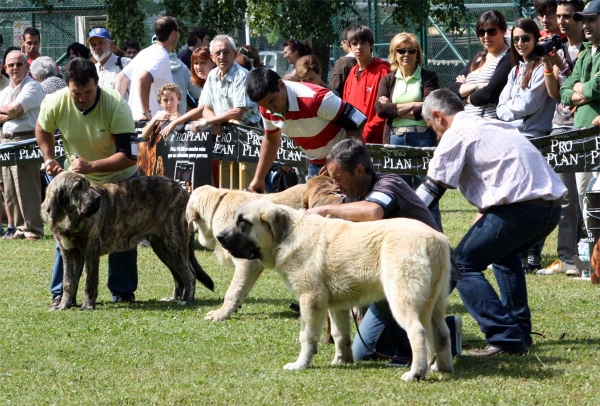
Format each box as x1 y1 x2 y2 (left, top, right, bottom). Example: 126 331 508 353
560 0 600 258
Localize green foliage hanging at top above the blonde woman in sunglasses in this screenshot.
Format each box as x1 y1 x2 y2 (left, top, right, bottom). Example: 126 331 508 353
381 0 467 30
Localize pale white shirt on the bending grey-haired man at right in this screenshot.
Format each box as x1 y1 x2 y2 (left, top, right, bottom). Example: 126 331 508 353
427 112 567 210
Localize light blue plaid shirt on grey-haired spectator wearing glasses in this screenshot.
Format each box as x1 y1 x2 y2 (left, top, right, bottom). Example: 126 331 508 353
200 62 261 126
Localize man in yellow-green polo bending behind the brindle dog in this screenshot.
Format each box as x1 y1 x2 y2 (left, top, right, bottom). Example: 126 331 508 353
35 58 137 309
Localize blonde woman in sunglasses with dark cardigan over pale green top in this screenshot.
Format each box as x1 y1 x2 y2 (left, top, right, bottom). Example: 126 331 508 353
375 32 442 228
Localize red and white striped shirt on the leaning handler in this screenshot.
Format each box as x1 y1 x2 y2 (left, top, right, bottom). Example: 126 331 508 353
260 80 346 163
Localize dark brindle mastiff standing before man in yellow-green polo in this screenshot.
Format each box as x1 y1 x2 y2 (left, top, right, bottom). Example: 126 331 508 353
41 171 213 310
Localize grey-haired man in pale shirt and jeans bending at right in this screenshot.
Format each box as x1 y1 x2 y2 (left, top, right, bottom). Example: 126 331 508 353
417 89 567 357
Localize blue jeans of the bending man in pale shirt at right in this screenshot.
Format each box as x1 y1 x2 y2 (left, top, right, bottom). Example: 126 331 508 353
454 203 561 352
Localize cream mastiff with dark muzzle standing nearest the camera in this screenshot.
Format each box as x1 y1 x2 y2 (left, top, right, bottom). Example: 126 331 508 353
217 201 453 381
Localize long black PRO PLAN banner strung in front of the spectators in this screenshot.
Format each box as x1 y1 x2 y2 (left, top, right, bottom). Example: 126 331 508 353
0 122 600 176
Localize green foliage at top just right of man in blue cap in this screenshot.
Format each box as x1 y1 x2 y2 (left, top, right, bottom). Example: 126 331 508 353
105 0 146 47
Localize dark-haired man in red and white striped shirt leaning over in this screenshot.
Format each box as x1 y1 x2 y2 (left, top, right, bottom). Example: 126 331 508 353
246 68 347 192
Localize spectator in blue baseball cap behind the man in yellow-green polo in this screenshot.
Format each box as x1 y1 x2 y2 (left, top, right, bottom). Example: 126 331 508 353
88 27 131 92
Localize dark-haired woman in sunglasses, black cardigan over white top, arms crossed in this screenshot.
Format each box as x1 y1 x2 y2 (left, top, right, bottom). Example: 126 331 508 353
448 10 511 118
